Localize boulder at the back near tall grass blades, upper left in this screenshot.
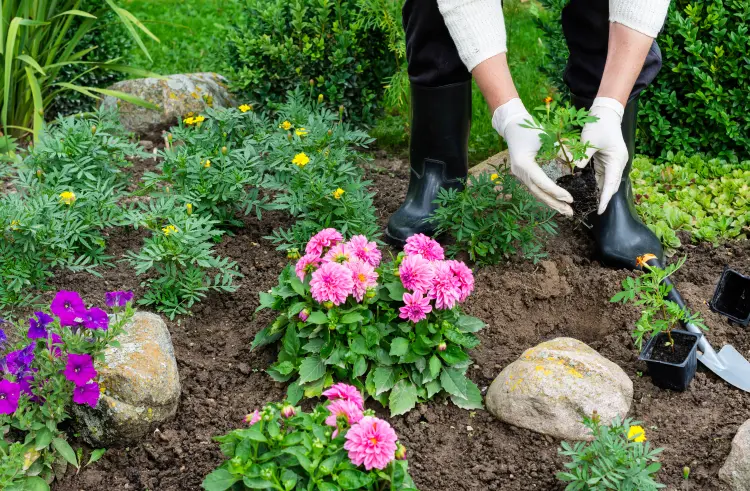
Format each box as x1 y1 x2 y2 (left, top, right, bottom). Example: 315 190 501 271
101 73 235 139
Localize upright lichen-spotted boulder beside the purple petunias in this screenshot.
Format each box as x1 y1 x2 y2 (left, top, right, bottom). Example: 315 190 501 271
75 312 181 447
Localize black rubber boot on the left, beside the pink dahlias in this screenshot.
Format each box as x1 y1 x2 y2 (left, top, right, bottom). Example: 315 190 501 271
385 81 471 250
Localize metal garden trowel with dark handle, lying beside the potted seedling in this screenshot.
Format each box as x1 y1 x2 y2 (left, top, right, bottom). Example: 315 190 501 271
646 258 750 392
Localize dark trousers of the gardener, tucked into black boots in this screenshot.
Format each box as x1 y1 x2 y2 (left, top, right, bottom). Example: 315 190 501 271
403 0 661 99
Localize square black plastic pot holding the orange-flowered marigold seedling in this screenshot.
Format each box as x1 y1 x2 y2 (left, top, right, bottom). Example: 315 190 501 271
638 331 701 391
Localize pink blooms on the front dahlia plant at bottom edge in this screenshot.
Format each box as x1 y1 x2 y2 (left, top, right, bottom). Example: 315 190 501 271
323 384 399 471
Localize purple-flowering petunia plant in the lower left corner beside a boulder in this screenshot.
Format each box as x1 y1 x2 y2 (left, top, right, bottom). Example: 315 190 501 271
0 291 133 489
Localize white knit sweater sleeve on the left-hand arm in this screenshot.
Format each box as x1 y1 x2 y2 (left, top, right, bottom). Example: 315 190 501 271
437 0 507 71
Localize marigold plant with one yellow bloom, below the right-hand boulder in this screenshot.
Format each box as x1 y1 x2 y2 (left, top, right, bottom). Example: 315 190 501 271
557 412 665 491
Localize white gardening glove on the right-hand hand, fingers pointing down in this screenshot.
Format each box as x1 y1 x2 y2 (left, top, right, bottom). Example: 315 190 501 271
576 97 628 215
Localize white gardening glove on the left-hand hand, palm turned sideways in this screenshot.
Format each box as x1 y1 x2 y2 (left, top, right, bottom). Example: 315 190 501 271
492 98 573 216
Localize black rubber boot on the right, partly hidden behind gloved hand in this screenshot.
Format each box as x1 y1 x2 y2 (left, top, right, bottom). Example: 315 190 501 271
573 96 664 269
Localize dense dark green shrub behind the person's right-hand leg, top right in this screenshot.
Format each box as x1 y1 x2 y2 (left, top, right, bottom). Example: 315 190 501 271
541 0 750 160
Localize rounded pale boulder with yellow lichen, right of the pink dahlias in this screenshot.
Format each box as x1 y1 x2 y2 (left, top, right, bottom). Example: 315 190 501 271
486 338 633 440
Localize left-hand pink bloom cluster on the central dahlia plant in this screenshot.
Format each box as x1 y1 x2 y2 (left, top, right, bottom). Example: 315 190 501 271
294 228 381 305
